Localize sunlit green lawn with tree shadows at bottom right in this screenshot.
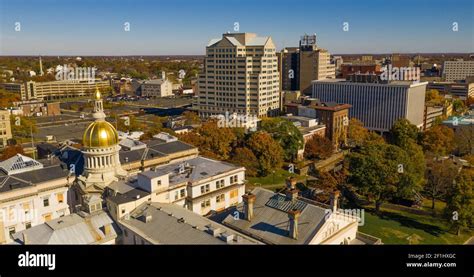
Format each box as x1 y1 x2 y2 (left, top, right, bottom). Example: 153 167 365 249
359 200 474 244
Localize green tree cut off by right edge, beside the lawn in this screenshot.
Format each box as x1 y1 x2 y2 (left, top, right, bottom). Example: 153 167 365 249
444 170 474 235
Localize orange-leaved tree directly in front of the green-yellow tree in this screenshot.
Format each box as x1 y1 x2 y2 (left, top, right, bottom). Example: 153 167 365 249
247 132 284 176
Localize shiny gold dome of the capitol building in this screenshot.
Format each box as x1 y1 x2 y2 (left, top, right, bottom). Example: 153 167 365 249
82 121 118 148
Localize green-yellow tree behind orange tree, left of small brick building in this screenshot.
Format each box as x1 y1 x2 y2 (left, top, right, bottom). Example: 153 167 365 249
260 118 304 161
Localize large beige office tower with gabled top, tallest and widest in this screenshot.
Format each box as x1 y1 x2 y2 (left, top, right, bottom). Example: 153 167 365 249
194 33 280 117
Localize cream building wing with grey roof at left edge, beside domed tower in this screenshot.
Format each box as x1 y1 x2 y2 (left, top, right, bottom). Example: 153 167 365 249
0 155 72 244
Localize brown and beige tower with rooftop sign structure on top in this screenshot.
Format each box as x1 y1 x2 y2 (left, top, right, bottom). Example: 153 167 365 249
299 35 336 95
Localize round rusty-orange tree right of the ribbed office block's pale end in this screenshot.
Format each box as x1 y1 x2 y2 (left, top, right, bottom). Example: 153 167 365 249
421 125 454 156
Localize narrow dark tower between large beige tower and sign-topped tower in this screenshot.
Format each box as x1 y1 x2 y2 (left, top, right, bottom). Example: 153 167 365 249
277 47 300 91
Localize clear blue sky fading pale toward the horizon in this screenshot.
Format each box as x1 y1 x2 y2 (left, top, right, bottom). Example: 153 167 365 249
0 0 474 56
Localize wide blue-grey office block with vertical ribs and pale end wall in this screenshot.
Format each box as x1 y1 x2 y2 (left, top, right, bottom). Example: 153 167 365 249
312 79 428 132
